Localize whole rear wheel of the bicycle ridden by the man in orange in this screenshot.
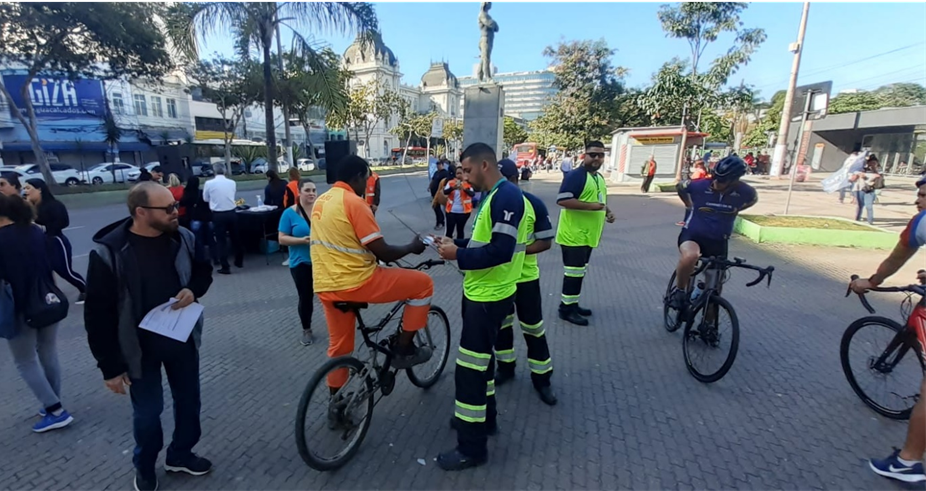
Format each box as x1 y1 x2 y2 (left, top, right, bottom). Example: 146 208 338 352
296 356 375 471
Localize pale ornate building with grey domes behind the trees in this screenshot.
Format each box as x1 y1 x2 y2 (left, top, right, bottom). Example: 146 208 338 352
342 36 463 160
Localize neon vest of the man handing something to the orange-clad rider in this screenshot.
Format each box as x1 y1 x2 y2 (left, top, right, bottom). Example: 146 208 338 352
463 188 534 302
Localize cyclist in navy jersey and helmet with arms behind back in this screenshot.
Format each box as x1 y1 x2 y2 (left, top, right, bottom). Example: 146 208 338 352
671 155 758 309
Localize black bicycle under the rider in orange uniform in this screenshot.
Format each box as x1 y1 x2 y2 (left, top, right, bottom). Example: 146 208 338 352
296 260 450 471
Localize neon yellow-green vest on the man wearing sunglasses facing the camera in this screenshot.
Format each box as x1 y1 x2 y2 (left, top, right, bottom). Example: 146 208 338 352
556 173 608 247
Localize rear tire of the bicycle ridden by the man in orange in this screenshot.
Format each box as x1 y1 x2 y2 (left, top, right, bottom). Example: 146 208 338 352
296 356 375 472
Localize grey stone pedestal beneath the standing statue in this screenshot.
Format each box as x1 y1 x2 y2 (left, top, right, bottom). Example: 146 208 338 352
463 82 506 159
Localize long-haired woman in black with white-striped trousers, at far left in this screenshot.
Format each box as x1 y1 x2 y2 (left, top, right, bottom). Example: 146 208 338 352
23 179 87 305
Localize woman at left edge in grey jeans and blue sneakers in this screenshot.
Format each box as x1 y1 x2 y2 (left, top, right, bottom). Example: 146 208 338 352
0 195 74 433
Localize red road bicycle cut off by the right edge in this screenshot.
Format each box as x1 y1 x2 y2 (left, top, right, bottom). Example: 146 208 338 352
839 275 926 420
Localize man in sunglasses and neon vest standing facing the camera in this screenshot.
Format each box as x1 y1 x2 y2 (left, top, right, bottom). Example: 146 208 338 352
556 141 614 326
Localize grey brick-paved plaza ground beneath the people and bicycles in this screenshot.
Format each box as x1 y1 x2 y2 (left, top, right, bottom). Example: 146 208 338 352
0 174 926 491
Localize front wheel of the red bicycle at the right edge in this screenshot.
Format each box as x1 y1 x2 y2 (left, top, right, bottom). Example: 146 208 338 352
839 316 926 420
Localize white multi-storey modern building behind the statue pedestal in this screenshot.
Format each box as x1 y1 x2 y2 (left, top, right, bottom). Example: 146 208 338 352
459 70 557 121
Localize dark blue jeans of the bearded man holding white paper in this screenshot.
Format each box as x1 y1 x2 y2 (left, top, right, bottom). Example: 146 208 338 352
129 336 202 477
